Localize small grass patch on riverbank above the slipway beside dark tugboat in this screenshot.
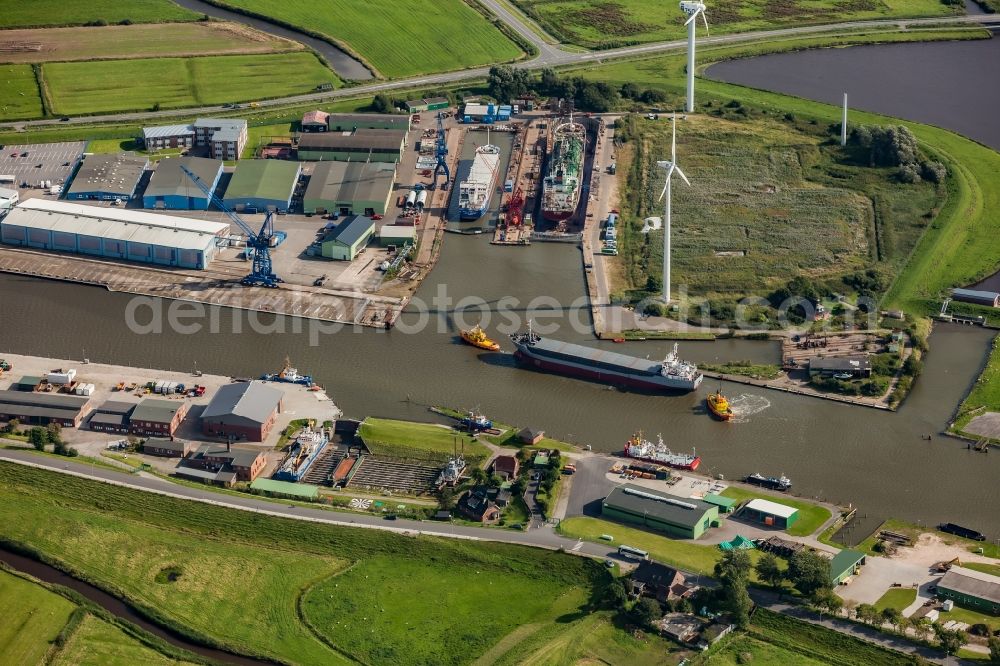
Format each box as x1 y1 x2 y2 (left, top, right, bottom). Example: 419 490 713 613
359 417 490 464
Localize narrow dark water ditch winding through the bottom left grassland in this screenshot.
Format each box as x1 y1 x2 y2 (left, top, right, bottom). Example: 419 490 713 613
0 548 277 666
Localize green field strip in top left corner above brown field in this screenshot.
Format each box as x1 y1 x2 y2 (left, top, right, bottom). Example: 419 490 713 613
0 0 201 28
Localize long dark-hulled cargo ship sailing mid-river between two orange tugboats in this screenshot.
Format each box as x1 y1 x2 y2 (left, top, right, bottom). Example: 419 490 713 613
510 324 703 392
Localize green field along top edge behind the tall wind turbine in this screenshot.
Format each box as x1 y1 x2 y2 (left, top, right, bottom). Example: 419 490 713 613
514 0 962 49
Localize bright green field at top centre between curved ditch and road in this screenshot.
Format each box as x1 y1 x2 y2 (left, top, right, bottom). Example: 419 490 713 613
213 0 522 78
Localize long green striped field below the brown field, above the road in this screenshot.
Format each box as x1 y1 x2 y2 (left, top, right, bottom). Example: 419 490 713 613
43 53 340 115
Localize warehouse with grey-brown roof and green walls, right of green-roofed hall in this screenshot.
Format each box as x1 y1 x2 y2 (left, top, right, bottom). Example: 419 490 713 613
302 162 396 217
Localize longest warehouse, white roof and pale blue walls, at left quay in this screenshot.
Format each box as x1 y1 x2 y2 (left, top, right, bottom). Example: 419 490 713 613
0 199 229 269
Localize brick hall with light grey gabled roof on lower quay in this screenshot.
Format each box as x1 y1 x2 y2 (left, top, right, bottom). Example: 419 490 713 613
201 382 284 442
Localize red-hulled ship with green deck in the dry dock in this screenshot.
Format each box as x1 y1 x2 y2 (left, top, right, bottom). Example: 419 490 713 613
542 116 587 222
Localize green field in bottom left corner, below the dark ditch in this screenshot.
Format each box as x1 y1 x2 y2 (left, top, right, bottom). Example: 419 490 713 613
0 570 76 664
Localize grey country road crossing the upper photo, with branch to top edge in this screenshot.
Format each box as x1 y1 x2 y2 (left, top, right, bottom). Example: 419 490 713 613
0 12 1000 130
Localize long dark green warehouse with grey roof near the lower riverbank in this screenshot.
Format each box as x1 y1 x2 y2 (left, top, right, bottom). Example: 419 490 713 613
601 483 719 539
